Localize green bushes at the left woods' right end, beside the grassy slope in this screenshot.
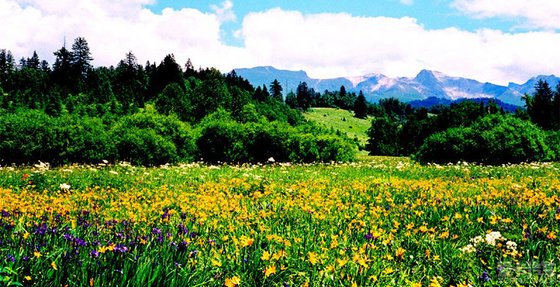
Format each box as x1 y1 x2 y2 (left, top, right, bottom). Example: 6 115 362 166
196 111 355 163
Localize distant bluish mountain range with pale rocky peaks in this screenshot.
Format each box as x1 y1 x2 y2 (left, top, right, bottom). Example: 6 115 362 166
235 66 560 106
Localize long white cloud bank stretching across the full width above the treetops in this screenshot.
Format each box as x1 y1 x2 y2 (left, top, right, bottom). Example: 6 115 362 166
0 0 560 84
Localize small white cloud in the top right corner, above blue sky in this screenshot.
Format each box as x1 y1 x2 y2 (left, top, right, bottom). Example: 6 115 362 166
452 0 560 30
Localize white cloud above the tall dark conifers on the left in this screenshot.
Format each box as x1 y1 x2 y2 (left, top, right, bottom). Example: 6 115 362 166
0 0 247 71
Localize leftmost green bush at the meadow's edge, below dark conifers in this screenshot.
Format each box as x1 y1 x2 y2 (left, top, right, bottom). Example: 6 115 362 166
0 110 116 164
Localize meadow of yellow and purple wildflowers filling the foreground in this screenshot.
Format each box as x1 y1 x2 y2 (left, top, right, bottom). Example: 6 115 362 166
0 158 560 287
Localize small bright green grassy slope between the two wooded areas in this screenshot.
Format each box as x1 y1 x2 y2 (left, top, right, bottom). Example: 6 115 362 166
304 108 371 145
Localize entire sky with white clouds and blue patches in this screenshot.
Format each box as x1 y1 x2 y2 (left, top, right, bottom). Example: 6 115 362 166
0 0 560 85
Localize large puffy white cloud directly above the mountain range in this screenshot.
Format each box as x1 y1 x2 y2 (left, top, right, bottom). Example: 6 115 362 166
241 9 560 84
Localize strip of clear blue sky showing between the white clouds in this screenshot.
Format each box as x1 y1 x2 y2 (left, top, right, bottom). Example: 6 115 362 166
147 0 520 46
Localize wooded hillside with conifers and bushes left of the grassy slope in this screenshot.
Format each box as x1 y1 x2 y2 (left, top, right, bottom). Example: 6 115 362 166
0 38 355 165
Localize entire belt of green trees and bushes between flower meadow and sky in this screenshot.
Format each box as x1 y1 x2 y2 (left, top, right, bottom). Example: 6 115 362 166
0 37 560 165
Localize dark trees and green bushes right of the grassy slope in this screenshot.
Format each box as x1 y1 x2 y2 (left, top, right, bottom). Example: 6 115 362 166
366 81 560 164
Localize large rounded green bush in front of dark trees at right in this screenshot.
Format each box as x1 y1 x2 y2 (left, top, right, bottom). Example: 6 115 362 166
416 115 553 164
